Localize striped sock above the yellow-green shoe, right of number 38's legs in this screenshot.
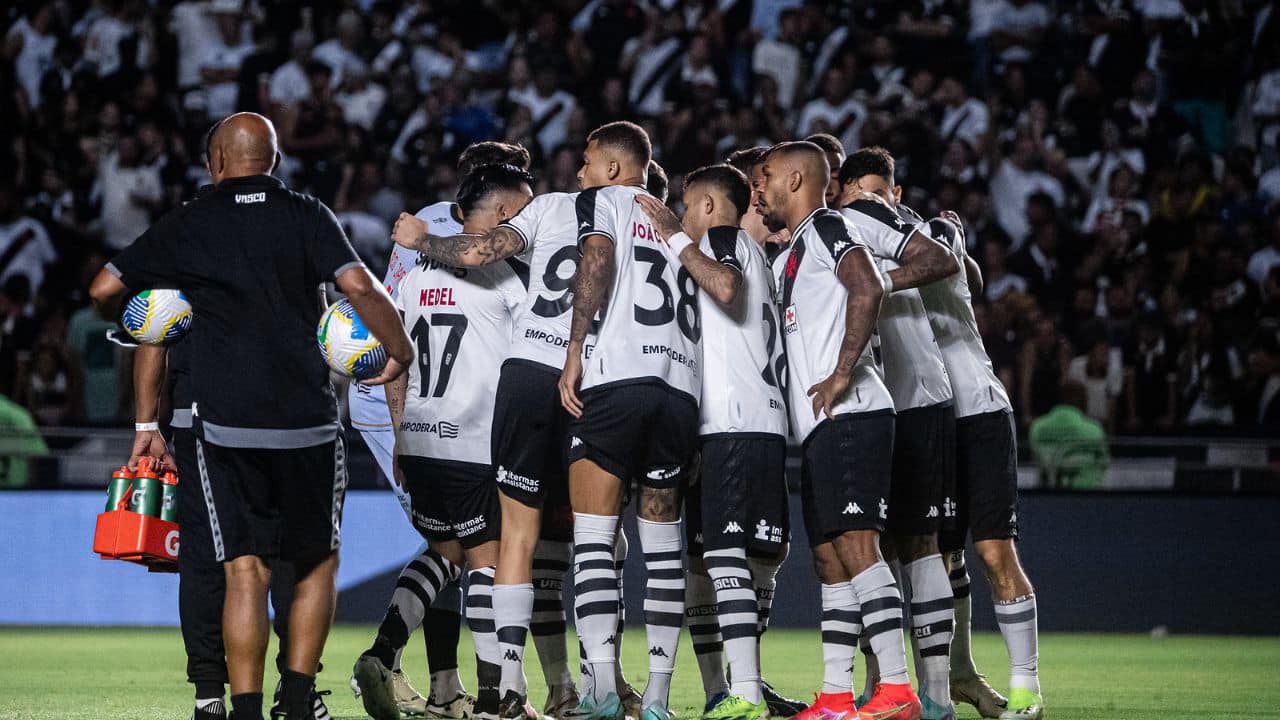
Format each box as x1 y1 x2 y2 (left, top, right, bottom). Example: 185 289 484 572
705 547 762 703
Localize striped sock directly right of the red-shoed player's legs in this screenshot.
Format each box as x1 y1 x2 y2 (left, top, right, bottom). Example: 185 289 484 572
902 555 955 707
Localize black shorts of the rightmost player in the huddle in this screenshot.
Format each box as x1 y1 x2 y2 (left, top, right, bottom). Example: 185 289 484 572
938 410 1018 551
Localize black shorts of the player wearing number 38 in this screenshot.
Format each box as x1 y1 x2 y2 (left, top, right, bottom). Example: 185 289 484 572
568 380 698 488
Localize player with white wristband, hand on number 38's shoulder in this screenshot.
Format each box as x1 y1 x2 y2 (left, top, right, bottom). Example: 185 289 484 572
636 165 788 720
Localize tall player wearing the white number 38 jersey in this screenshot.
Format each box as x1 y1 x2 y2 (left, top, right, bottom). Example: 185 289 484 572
559 122 701 720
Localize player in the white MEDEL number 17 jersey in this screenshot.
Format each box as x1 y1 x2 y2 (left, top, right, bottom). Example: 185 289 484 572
353 165 532 720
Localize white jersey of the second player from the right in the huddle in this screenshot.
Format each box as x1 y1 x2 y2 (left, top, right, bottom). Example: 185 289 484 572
841 200 951 410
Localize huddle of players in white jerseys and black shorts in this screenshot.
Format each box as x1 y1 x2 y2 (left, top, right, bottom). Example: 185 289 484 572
349 122 1043 720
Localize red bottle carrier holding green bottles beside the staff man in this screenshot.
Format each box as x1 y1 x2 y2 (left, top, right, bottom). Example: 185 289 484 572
93 457 178 573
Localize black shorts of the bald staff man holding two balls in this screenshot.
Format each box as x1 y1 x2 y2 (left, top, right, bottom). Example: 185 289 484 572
192 433 347 564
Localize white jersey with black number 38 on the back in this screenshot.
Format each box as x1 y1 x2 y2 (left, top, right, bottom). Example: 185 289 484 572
577 186 701 402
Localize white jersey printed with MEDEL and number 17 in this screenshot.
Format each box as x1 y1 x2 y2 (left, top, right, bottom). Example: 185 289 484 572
396 254 526 464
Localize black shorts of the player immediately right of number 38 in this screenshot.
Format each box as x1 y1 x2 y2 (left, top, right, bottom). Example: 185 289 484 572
685 433 791 557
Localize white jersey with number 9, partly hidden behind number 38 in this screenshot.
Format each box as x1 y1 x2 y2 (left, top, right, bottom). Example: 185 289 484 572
502 192 581 372
